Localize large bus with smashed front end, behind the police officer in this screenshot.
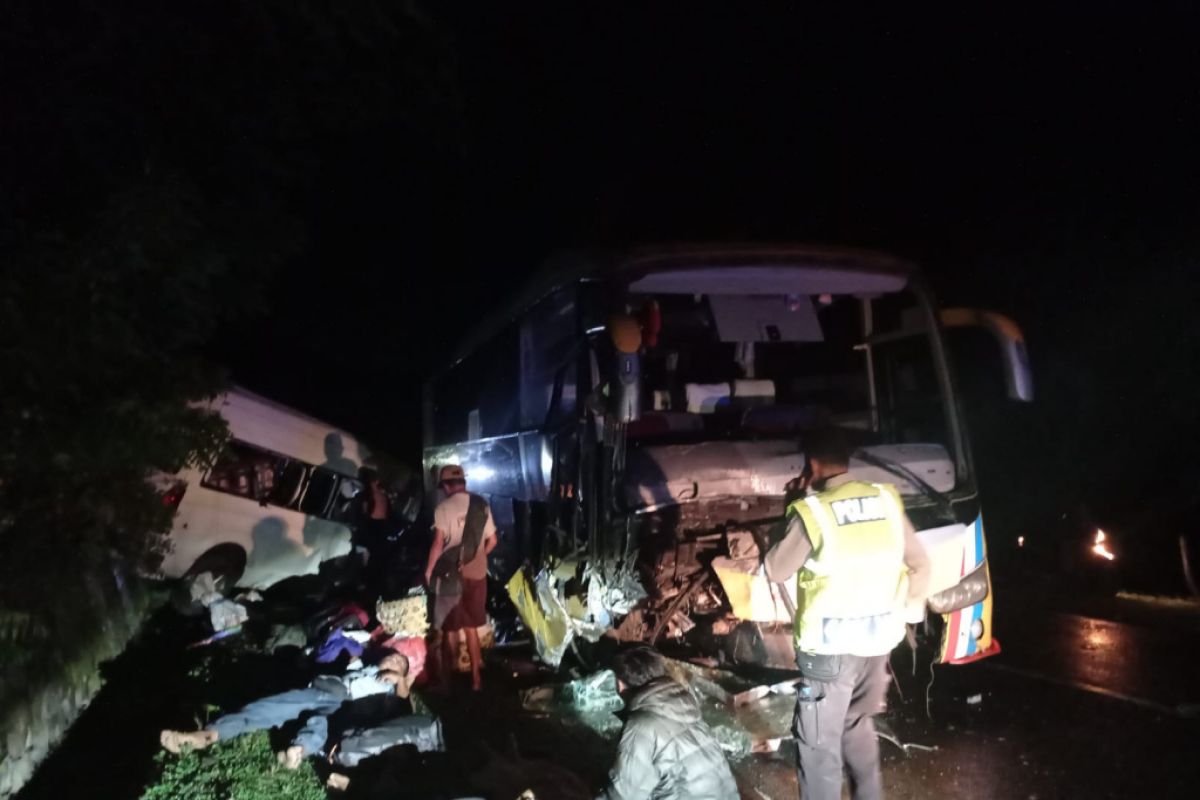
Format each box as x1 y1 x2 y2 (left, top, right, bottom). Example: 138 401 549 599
424 246 1032 667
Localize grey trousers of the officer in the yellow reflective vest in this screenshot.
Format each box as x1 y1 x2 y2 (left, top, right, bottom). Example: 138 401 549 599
792 656 888 800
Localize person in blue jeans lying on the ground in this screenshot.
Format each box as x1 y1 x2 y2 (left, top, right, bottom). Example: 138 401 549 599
160 652 412 769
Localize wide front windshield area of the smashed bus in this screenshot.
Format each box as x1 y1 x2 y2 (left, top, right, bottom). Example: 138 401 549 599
626 281 958 482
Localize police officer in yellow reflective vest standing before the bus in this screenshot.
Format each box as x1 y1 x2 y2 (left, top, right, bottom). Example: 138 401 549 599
764 428 930 800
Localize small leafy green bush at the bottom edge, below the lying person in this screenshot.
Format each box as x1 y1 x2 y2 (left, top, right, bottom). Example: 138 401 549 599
142 733 325 800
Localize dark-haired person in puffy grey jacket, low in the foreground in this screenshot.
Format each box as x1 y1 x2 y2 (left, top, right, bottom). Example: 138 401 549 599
599 645 738 800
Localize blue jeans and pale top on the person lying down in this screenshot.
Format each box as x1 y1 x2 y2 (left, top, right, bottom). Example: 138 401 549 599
208 667 396 756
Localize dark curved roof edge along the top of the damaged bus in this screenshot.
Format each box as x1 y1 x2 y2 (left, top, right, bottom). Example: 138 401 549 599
438 243 917 374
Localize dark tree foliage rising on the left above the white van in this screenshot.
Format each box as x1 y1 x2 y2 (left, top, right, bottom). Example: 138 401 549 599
0 0 456 630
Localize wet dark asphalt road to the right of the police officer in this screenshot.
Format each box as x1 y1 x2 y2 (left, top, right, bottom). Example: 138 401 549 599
738 599 1200 800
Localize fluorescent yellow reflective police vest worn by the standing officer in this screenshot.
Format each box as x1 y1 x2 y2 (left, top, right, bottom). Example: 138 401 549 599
788 481 908 656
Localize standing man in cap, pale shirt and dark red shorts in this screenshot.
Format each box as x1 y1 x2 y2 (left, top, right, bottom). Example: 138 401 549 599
425 464 497 692
